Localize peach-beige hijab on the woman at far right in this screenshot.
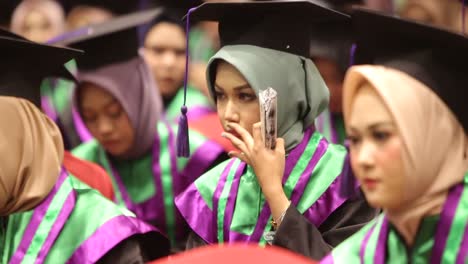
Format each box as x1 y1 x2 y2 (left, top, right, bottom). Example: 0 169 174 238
343 65 468 244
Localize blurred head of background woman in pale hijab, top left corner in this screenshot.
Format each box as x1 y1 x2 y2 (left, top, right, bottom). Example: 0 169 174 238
10 0 66 43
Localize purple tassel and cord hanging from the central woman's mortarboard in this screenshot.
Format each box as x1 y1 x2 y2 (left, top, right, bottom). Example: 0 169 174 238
177 8 196 158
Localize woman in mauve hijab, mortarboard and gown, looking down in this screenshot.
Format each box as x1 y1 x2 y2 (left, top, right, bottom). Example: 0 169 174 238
54 10 225 250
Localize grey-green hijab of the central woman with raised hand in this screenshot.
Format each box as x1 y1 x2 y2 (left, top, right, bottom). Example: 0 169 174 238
207 45 329 152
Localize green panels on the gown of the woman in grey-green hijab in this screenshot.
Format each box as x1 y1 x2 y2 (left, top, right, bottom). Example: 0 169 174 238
195 132 346 244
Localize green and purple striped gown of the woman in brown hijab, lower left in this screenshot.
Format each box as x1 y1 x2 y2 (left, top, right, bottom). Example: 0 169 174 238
0 169 169 264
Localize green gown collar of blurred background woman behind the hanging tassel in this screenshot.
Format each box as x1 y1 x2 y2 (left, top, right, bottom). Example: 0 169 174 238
166 86 213 121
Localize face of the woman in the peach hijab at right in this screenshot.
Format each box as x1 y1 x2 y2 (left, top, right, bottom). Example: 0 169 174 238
346 84 406 210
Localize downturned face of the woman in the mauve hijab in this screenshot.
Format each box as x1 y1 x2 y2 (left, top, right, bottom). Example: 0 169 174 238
79 83 135 157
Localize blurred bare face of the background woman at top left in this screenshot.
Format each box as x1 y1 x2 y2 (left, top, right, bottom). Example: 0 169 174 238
20 10 56 43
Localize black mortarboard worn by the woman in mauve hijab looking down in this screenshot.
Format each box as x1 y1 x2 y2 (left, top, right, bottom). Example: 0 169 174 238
49 8 161 70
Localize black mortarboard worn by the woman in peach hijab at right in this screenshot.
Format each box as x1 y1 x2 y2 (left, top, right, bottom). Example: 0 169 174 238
352 9 468 132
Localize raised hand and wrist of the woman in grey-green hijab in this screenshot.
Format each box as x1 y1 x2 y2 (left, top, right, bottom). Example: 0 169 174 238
223 123 289 223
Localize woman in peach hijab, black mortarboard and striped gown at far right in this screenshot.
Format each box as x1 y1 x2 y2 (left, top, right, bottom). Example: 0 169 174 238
323 10 468 263
